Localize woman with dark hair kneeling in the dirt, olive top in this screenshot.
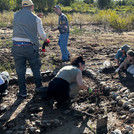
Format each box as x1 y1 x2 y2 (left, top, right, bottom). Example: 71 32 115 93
47 56 89 105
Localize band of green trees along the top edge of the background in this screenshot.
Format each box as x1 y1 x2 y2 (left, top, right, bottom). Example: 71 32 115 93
0 0 134 11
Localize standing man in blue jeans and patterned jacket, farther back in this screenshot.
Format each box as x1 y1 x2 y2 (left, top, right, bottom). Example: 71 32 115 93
52 5 70 62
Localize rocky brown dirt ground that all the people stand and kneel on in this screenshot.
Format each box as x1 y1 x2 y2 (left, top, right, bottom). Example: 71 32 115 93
0 24 134 134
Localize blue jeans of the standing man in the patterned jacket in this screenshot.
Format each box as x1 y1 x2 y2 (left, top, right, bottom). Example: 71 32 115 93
59 33 69 61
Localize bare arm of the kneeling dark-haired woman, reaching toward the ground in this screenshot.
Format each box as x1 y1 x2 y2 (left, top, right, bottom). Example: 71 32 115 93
76 72 88 90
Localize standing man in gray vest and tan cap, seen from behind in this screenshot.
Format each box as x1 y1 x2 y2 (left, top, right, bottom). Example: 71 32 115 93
12 0 47 98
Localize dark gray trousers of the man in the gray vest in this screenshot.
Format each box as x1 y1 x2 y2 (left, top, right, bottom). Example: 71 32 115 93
12 45 42 95
